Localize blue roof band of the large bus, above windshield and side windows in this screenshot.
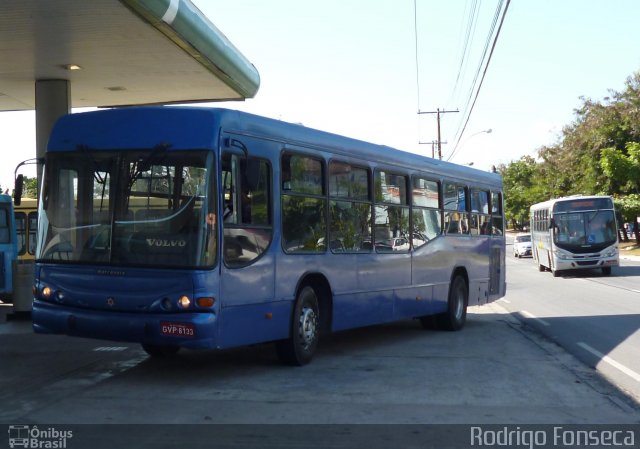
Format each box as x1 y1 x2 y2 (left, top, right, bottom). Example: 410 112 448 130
47 106 502 188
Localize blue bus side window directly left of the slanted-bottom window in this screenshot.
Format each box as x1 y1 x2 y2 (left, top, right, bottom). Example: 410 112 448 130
374 170 411 253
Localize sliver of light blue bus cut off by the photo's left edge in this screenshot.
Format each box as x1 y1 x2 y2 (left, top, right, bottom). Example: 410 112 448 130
0 194 18 303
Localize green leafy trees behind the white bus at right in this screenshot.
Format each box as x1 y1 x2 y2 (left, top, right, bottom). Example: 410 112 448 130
500 72 640 228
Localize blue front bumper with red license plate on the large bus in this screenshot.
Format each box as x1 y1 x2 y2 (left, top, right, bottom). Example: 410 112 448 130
32 300 217 349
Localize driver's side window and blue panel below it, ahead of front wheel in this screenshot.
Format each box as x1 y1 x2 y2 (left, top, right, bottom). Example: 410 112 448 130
218 151 276 346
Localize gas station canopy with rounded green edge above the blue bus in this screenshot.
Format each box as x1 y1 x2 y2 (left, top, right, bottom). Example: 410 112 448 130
0 0 260 111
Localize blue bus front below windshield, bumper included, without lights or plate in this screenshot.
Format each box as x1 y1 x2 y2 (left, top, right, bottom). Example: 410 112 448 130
32 264 219 348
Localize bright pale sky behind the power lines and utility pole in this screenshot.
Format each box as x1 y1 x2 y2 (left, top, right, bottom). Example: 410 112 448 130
0 0 640 190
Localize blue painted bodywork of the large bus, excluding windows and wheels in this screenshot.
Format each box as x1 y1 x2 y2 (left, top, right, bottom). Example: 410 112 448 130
33 107 505 348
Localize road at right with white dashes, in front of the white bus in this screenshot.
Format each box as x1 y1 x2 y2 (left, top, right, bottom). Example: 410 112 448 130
499 240 640 402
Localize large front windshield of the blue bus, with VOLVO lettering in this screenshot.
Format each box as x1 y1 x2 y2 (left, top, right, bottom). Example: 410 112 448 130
36 147 217 267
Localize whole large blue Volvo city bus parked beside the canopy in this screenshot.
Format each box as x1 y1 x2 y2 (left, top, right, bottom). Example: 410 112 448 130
26 106 506 365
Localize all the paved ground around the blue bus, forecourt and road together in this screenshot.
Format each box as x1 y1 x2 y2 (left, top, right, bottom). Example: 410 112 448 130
0 247 640 449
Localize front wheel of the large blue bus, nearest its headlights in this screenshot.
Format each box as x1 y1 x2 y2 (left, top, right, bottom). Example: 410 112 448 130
276 285 320 366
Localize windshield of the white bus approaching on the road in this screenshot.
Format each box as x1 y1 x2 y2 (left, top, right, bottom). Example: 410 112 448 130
554 210 617 247
